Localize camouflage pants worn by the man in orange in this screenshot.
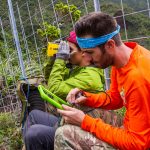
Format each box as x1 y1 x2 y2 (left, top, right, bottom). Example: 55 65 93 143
54 109 122 150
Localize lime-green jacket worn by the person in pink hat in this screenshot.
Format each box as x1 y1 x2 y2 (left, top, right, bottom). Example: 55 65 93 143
44 59 104 99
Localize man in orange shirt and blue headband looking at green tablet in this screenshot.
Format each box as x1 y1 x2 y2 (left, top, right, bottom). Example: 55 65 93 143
55 13 150 150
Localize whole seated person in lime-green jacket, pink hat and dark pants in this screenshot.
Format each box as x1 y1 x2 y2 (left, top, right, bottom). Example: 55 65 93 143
23 31 104 150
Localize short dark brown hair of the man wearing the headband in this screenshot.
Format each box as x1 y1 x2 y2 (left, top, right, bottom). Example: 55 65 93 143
75 12 121 46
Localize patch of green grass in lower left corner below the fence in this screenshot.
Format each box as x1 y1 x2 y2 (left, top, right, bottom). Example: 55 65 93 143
0 113 22 150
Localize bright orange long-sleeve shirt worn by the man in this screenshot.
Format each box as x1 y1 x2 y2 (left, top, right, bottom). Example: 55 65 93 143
81 42 150 150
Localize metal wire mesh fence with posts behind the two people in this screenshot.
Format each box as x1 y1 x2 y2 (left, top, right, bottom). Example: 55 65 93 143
0 0 150 112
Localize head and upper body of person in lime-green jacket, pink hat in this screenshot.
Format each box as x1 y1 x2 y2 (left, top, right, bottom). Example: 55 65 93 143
44 31 104 99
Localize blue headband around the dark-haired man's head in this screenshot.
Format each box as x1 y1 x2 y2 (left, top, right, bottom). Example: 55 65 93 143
76 25 120 48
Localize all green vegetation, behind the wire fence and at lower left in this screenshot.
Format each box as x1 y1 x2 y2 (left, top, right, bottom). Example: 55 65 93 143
0 0 150 150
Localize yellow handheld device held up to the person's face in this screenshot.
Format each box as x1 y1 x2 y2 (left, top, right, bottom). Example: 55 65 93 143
47 42 59 56
